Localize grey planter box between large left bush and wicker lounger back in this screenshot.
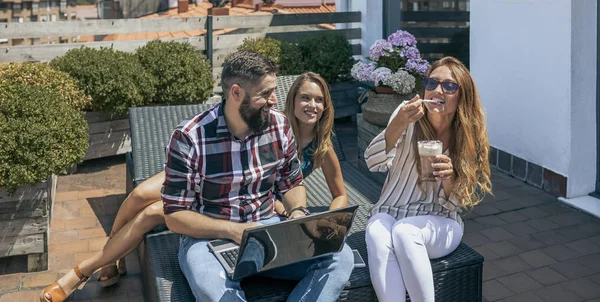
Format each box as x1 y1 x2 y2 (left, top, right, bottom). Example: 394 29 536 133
84 112 131 160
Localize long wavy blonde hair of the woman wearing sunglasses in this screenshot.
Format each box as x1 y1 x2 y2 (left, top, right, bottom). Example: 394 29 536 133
412 57 492 209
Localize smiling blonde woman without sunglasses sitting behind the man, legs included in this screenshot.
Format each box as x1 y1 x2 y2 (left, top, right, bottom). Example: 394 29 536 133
40 72 348 302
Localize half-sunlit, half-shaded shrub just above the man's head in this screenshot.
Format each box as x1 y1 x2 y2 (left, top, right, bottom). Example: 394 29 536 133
237 38 304 75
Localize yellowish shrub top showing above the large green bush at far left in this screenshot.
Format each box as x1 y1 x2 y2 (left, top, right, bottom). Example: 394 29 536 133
0 63 91 110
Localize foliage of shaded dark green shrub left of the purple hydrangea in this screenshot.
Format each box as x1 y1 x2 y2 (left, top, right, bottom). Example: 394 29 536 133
300 33 354 84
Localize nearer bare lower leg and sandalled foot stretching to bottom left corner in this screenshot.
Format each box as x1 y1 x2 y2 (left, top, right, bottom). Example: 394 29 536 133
46 201 165 301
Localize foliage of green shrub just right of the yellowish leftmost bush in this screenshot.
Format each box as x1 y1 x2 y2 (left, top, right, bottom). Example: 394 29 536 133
50 46 156 115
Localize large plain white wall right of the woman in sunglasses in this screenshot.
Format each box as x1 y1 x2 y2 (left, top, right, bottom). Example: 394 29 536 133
470 0 596 197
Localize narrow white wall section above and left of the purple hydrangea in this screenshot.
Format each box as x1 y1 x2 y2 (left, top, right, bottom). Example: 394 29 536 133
335 0 383 56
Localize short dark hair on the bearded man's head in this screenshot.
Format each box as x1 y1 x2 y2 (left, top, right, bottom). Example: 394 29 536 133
221 50 278 93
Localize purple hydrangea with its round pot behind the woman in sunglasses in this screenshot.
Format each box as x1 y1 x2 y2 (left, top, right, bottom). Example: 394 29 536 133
351 30 429 127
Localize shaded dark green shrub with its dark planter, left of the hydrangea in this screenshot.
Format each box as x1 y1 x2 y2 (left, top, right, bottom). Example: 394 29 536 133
300 33 358 118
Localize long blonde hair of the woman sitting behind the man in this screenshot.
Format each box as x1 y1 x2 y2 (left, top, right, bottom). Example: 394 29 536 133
285 72 334 169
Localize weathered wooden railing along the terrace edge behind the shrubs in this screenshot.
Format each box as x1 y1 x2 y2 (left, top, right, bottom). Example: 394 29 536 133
0 12 361 82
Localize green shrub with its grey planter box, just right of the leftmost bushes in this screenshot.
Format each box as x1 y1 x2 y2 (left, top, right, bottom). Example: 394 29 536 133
50 46 156 160
